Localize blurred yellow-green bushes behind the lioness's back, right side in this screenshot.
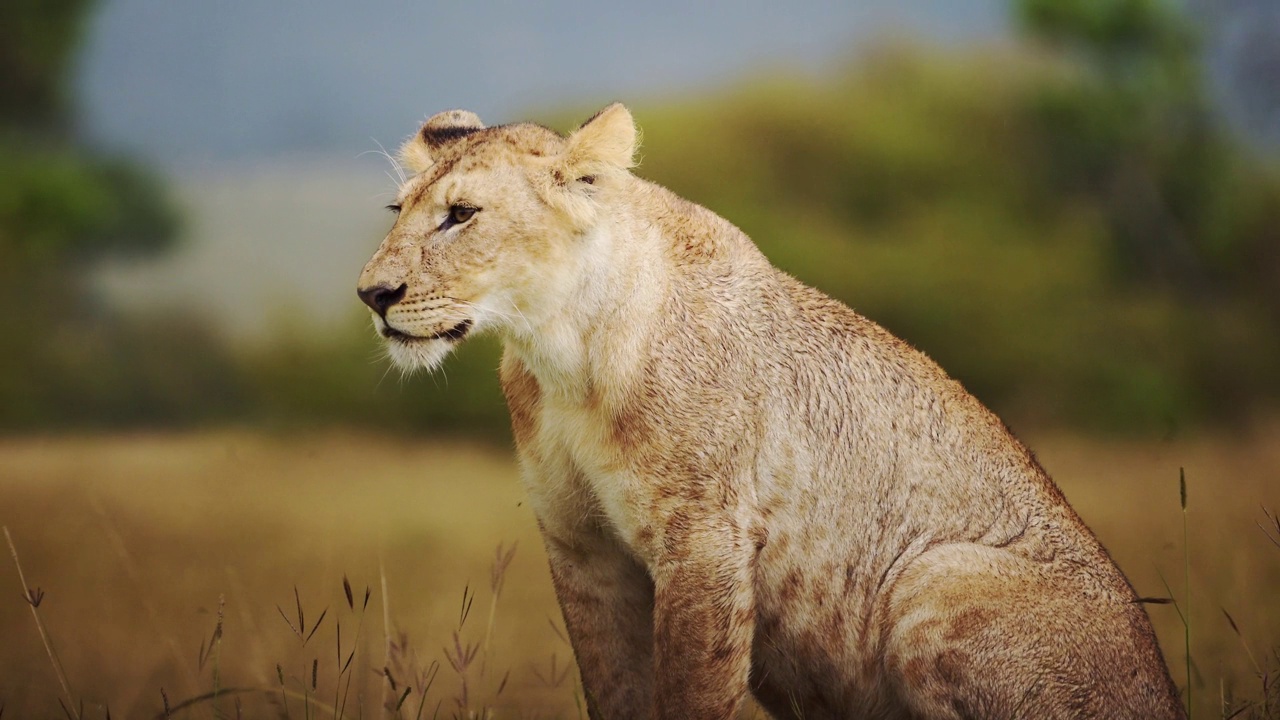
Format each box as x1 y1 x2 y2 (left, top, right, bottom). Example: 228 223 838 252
629 37 1280 432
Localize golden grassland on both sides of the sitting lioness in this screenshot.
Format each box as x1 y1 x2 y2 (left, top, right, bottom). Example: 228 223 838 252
0 423 1280 717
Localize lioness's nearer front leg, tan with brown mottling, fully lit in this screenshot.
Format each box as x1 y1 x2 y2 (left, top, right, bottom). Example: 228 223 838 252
654 523 755 720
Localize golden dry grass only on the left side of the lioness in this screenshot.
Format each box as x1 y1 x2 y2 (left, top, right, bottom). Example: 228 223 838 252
0 433 576 717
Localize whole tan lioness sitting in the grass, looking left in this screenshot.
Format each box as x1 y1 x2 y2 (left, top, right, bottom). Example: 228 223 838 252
358 105 1181 720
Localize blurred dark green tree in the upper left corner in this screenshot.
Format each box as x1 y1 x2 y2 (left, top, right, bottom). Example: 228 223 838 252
0 0 177 271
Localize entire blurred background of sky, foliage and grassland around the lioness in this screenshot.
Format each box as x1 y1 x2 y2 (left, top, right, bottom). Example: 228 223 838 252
0 0 1280 716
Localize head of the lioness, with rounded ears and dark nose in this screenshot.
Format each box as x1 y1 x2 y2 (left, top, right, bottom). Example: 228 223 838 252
357 105 635 369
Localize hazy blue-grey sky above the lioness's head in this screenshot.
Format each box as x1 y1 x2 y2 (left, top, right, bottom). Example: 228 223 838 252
78 0 1006 164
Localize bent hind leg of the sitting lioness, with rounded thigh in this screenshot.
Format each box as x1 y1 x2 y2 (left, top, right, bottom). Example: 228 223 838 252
883 544 1180 720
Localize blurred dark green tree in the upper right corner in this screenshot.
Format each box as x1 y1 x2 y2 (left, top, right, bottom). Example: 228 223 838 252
1015 0 1280 303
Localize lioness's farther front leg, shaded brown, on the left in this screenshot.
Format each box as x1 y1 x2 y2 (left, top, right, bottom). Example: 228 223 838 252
543 530 653 720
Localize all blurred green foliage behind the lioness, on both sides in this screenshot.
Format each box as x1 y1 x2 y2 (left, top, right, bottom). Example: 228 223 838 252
0 0 1280 438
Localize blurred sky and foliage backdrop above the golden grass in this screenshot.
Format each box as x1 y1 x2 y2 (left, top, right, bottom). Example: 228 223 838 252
0 0 1280 436
